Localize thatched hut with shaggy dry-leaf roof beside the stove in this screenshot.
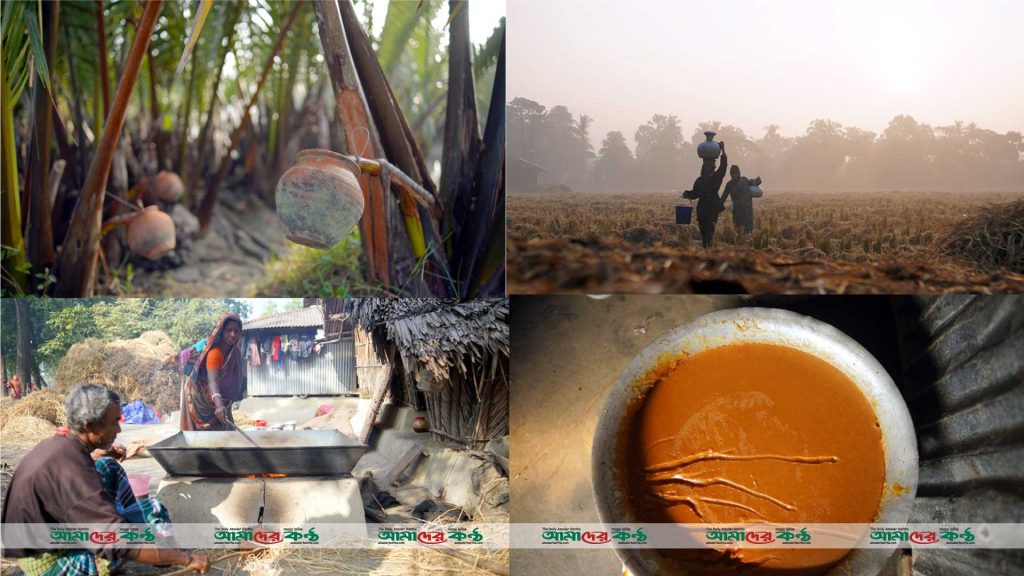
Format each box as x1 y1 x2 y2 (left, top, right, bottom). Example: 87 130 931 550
350 298 509 448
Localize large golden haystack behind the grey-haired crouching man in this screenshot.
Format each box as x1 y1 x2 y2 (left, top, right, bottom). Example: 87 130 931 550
54 332 180 413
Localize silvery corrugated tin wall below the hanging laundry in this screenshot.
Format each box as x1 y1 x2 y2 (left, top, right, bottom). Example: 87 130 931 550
247 338 358 396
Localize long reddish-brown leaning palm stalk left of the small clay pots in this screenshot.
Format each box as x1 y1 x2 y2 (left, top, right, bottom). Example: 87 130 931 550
57 0 164 297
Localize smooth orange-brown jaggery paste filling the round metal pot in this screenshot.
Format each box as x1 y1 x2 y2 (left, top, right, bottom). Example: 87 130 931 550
629 343 885 575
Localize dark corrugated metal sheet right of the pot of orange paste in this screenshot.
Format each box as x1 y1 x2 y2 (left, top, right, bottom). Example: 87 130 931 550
893 295 1024 576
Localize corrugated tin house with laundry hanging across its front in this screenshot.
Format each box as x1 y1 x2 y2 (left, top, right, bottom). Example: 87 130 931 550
242 301 358 397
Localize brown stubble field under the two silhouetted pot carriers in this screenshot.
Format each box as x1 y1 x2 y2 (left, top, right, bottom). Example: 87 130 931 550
508 192 1024 293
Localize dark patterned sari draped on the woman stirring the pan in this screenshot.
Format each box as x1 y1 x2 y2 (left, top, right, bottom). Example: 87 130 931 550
180 314 242 430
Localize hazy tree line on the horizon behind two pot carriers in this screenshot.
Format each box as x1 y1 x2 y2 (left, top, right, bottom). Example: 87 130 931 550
507 98 1024 191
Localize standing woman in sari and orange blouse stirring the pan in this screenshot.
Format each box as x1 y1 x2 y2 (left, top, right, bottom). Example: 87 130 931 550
180 314 242 430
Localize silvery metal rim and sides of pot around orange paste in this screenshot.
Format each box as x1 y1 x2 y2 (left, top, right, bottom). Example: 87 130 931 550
591 307 918 576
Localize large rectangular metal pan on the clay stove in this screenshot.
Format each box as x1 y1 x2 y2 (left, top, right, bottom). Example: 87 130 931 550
148 430 369 477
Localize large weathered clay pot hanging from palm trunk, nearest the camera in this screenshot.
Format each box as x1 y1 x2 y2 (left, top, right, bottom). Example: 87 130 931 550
276 150 364 249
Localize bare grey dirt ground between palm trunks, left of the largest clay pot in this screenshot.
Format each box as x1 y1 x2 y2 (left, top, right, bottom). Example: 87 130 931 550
128 189 288 297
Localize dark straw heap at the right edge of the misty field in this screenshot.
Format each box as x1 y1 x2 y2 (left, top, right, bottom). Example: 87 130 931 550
939 200 1024 274
